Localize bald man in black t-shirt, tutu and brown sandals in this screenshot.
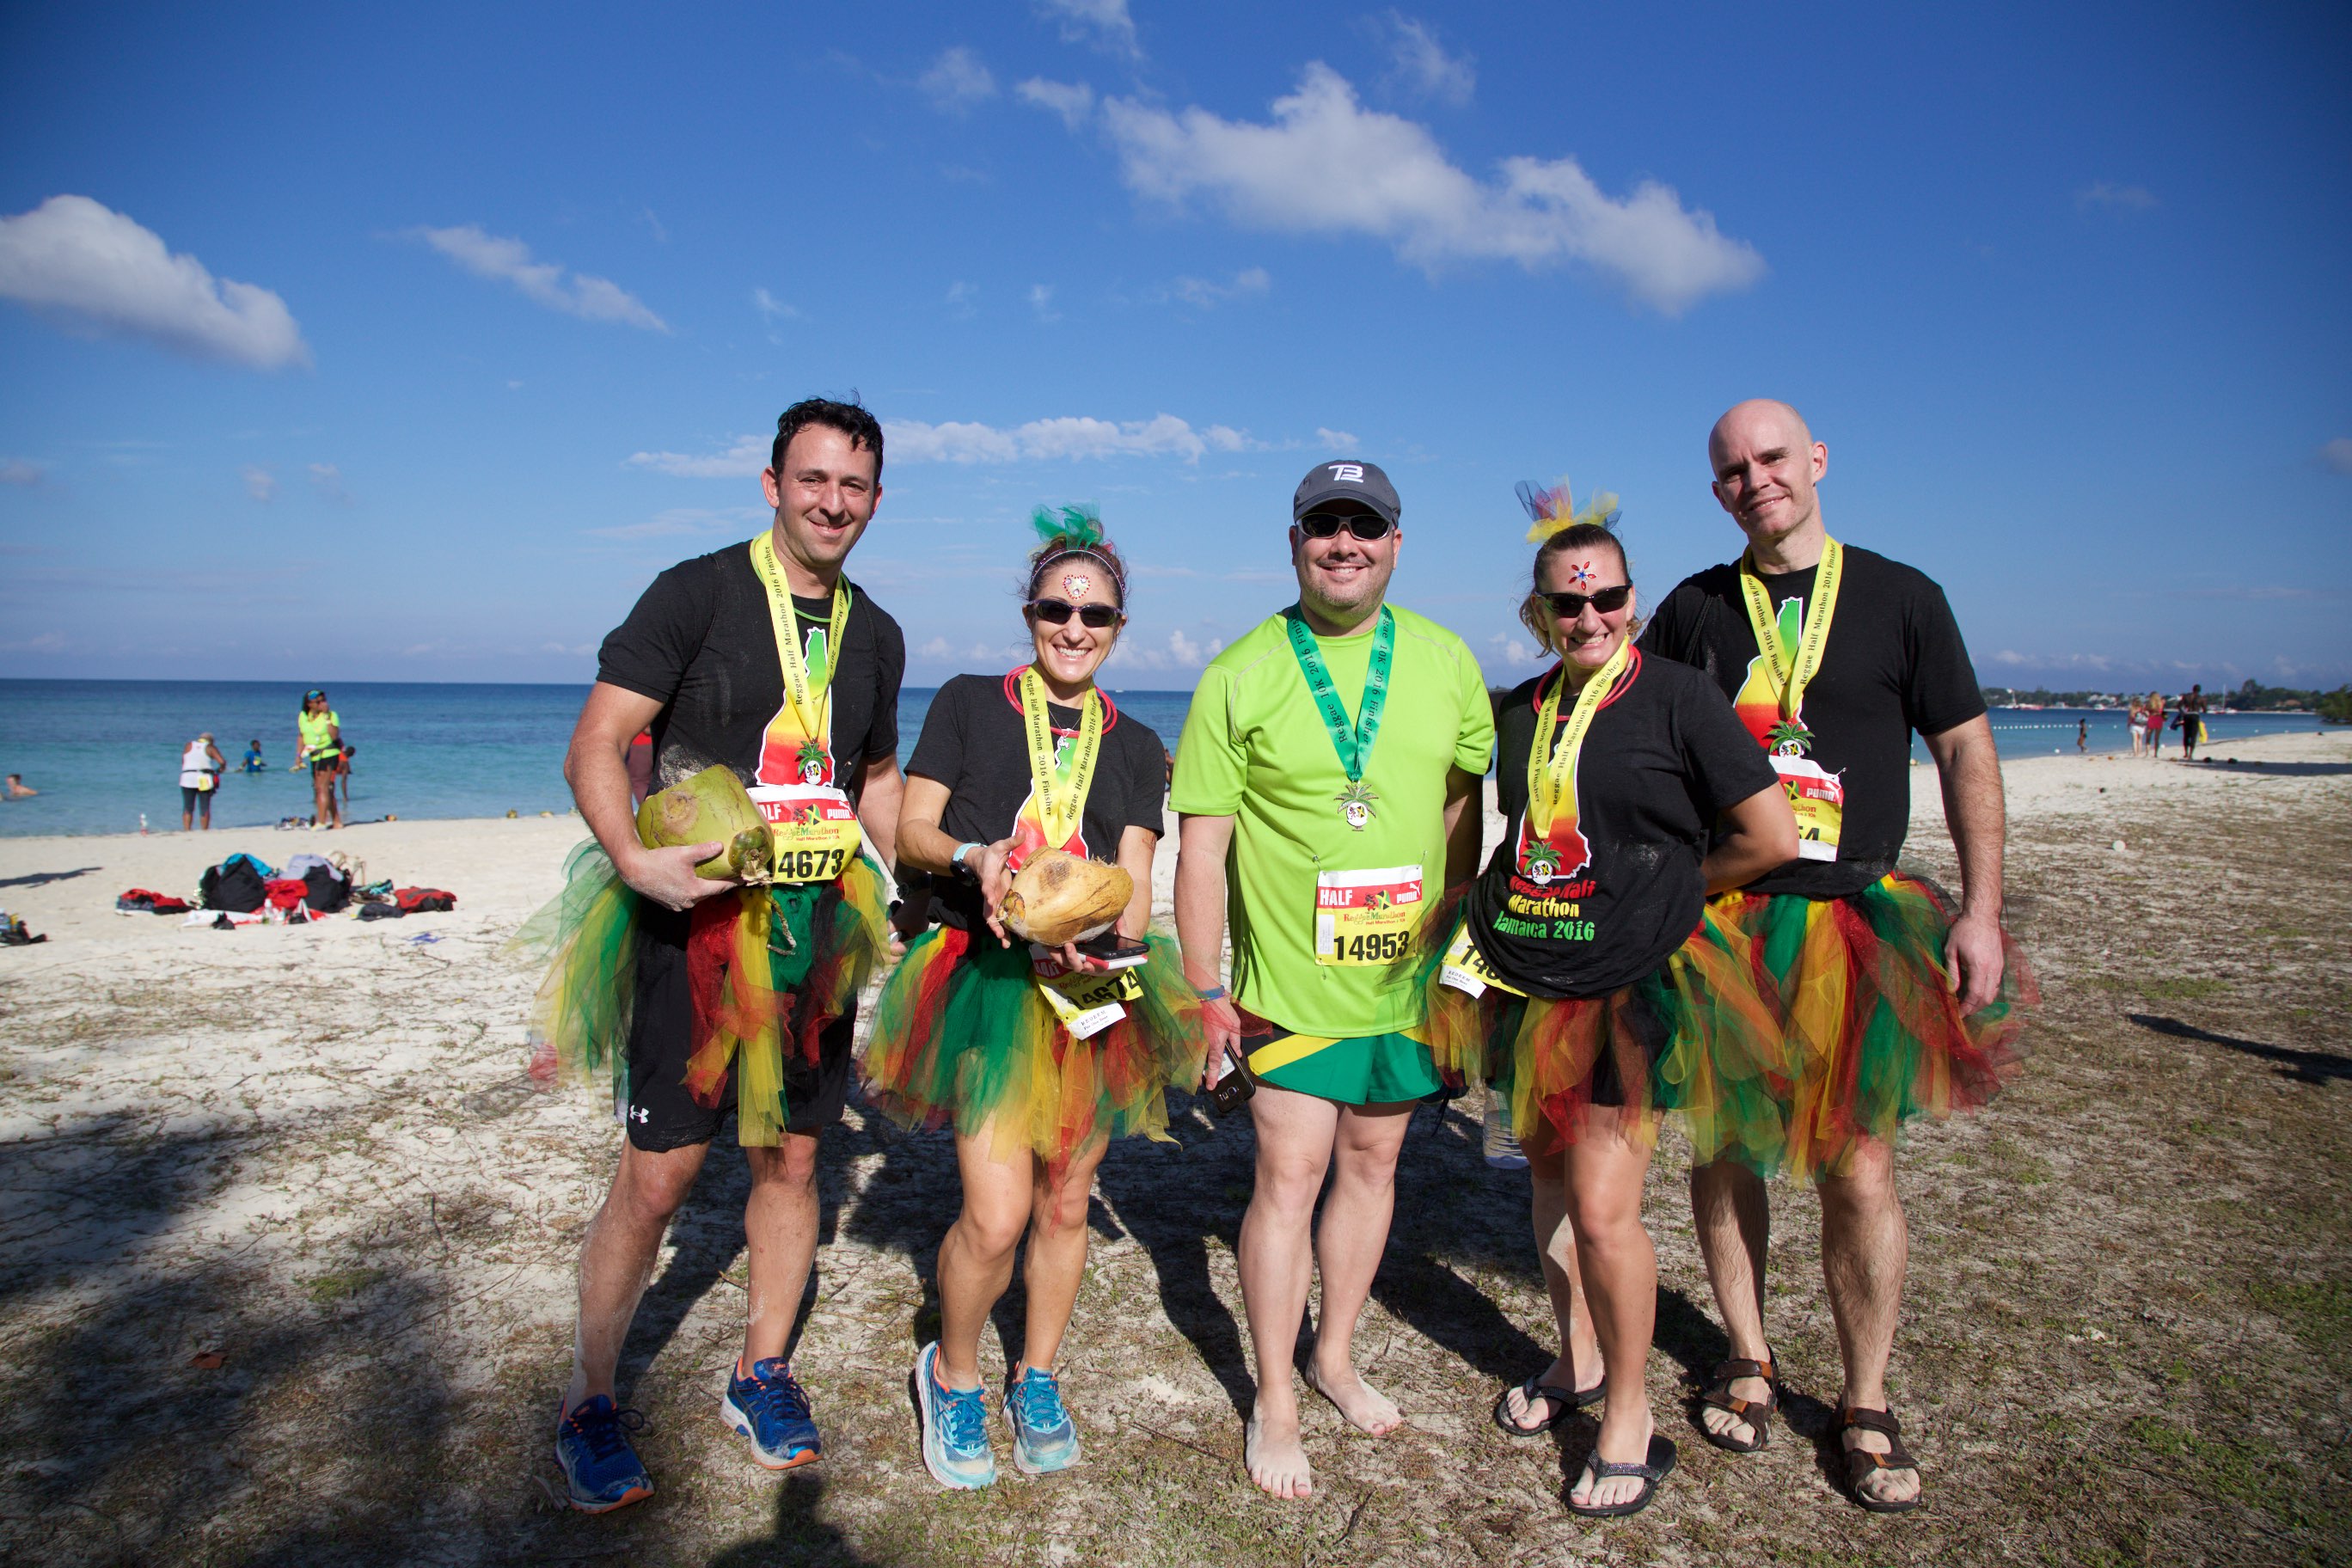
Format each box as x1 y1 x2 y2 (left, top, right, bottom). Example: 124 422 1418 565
1642 400 2030 1514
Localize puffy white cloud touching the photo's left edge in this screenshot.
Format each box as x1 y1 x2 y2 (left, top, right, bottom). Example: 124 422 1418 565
0 195 310 369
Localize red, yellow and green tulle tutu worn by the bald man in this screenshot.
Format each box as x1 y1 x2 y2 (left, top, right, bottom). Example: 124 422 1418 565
1707 873 2042 1175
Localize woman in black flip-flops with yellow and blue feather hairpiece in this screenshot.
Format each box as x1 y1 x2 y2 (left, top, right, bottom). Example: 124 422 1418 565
1418 492 1797 1514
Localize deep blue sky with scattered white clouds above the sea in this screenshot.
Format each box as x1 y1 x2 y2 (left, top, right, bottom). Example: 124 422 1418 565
0 0 2352 689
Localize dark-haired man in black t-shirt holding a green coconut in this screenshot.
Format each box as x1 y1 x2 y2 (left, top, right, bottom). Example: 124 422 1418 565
555 400 905 1514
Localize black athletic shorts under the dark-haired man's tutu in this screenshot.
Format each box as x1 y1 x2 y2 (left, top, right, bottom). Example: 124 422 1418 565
621 908 859 1155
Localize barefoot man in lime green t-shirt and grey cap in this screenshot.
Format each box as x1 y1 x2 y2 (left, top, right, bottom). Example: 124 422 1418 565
1169 461 1493 1498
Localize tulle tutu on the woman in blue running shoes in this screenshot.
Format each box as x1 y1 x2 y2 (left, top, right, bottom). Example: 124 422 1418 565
863 926 1202 1171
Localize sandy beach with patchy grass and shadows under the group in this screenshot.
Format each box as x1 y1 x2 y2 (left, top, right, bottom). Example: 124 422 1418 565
0 731 2352 1564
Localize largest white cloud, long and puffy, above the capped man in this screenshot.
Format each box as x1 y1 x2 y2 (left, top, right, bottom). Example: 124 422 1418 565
1103 61 1764 315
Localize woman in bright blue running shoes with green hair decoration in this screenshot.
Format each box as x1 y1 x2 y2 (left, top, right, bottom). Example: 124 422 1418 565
866 508 1202 1488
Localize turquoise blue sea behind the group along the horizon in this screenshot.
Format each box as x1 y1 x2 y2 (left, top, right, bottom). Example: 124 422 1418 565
0 679 2319 837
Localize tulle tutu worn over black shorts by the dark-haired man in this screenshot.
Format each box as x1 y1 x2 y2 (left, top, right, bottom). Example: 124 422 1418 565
515 844 889 1148
